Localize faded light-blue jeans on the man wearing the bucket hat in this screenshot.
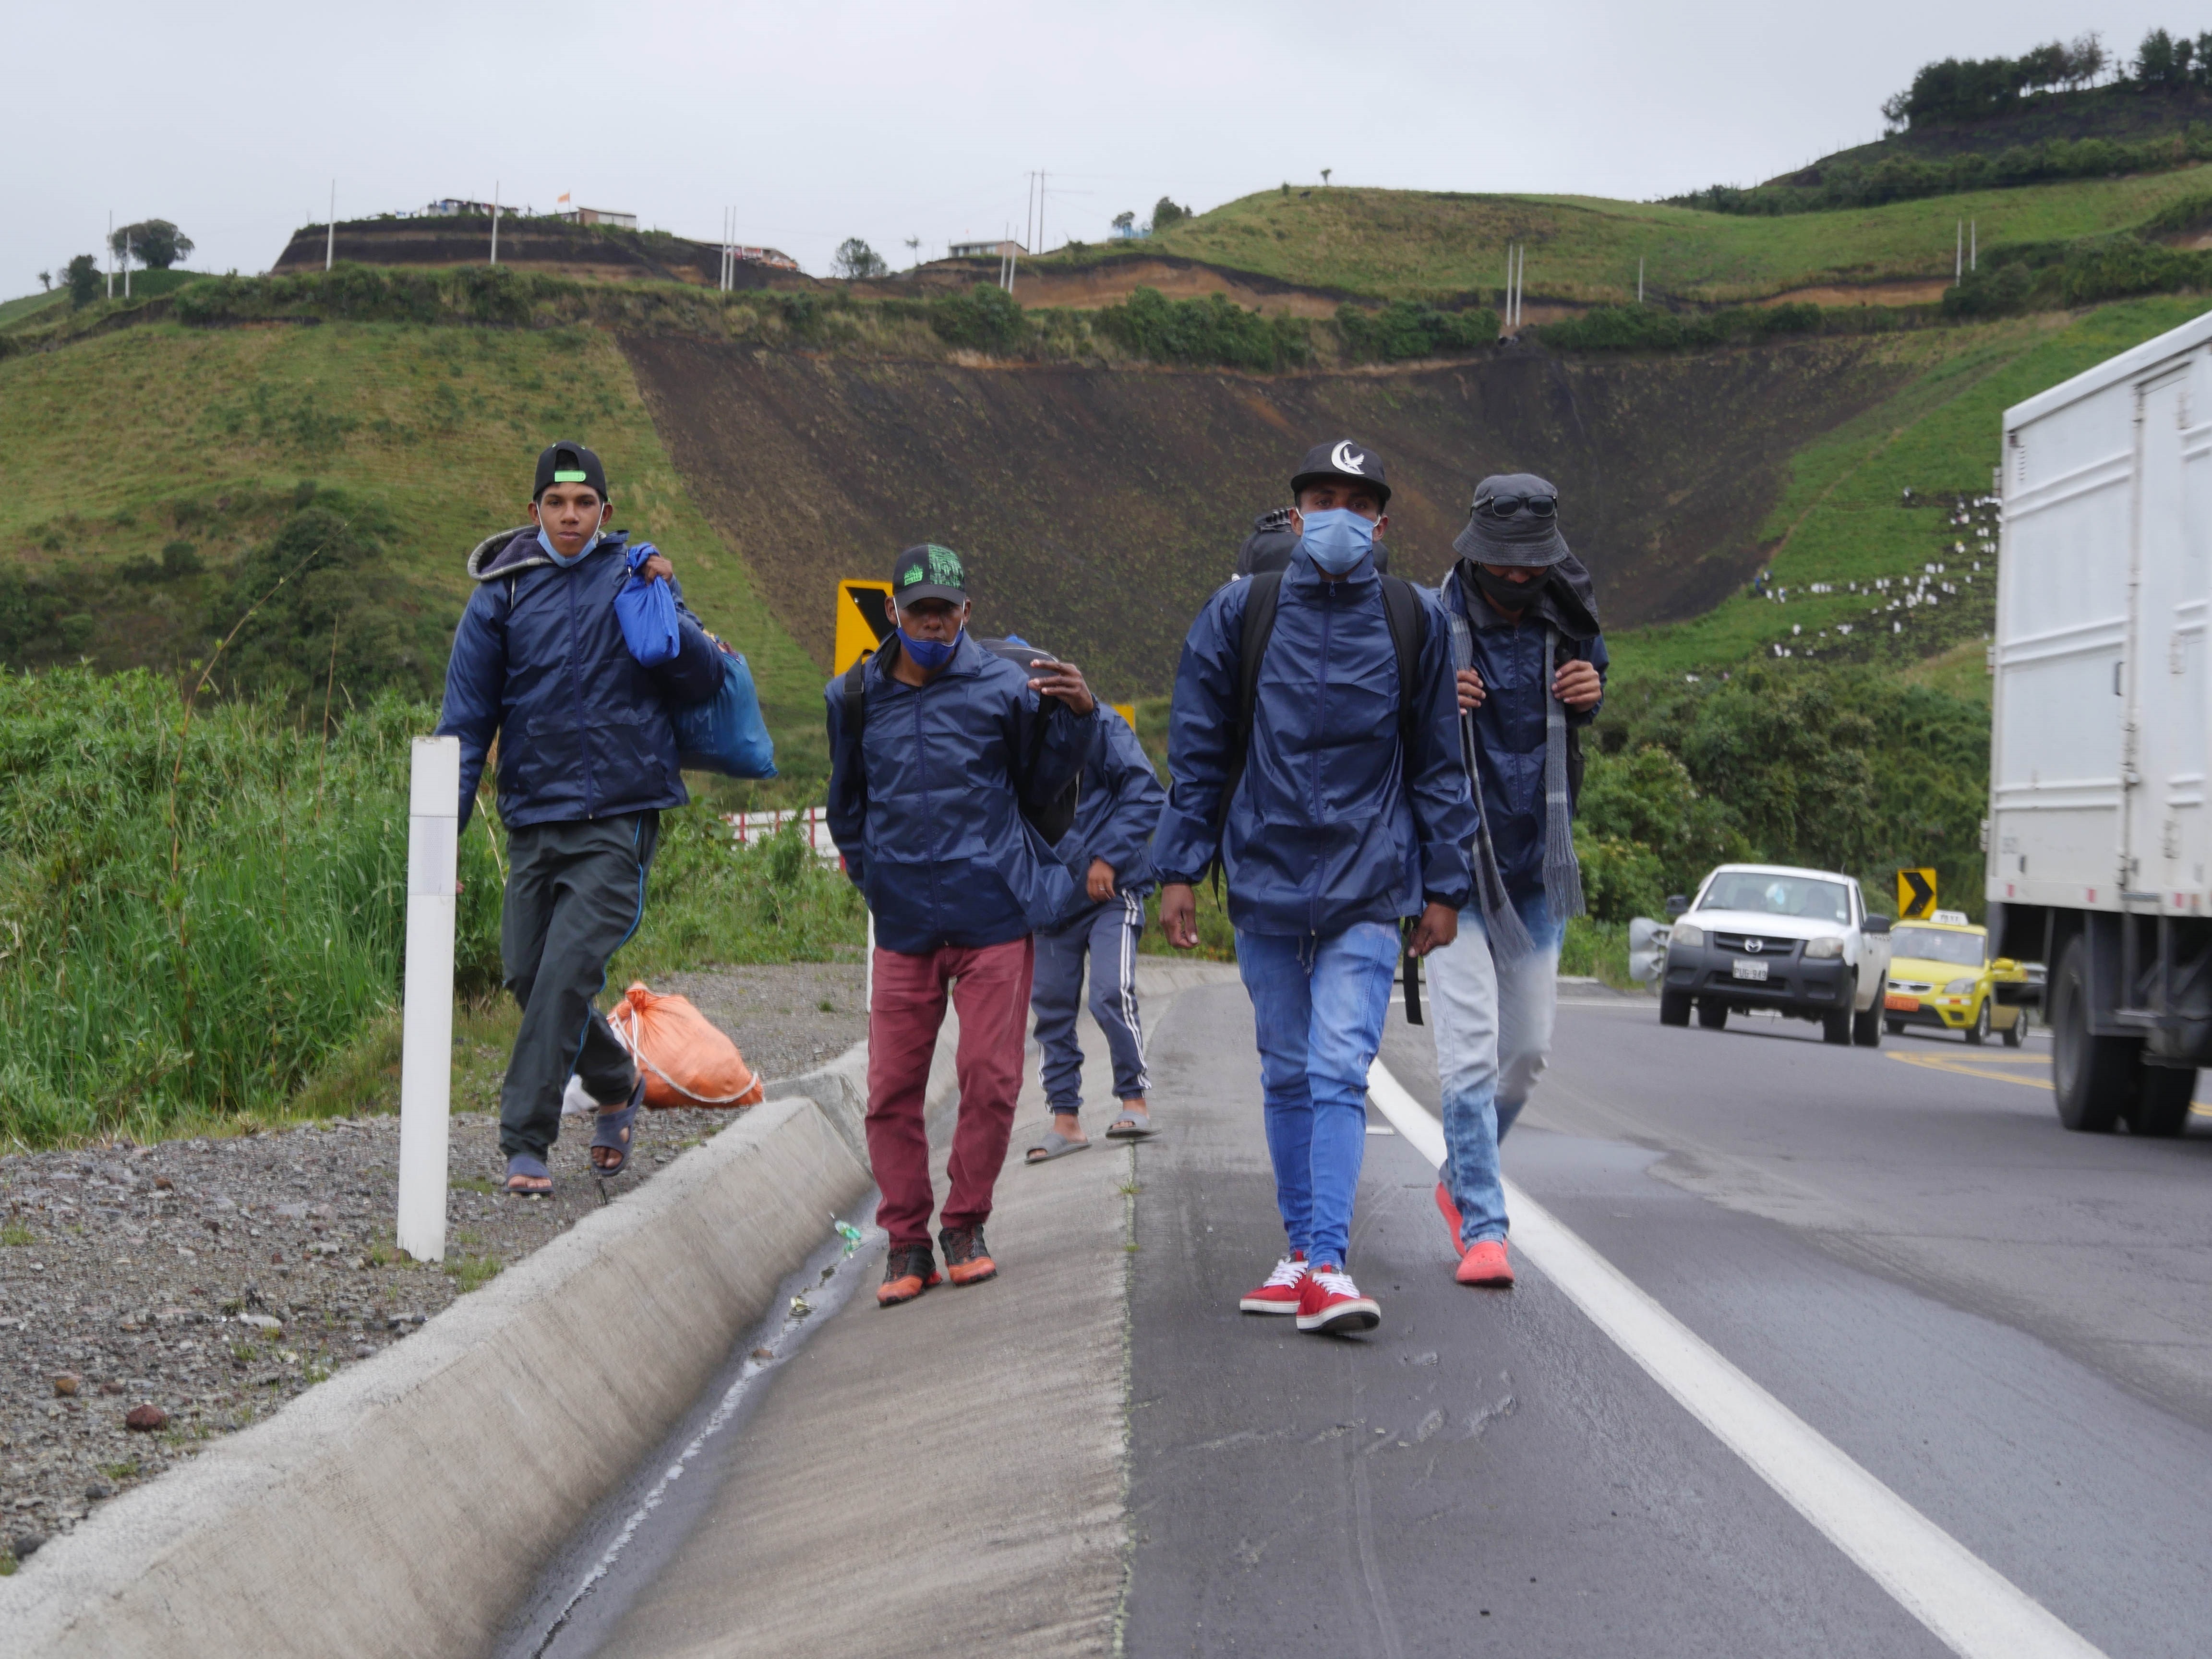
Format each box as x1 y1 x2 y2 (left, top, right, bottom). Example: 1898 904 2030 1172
1429 894 1566 1250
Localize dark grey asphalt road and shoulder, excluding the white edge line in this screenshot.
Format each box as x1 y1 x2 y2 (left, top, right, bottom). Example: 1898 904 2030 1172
1126 986 2212 1659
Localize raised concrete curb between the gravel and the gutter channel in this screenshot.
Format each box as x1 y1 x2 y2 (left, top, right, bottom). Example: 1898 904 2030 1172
0 1039 933 1659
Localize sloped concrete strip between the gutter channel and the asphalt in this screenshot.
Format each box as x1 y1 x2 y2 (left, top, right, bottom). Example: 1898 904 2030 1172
600 964 1234 1657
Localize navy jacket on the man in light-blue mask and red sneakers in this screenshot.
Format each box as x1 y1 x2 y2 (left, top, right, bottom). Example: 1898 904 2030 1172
1153 549 1476 934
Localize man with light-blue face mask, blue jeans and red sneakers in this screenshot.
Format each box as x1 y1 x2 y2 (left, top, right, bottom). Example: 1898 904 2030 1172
1153 440 1476 1334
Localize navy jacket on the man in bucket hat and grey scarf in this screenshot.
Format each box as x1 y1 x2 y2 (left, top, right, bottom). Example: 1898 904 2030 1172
1442 586 1611 898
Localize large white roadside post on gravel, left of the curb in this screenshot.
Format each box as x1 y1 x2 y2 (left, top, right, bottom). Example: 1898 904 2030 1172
396 736 460 1261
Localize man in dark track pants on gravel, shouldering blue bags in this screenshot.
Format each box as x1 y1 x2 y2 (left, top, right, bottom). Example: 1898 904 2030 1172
438 443 721 1194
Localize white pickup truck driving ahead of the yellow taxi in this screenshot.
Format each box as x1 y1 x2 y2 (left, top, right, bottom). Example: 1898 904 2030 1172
1655 865 1889 1048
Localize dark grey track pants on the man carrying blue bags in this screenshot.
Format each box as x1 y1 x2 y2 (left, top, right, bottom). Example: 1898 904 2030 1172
500 812 661 1157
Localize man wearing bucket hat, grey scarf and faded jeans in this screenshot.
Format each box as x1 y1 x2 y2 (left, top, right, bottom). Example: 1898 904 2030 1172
1429 473 1606 1287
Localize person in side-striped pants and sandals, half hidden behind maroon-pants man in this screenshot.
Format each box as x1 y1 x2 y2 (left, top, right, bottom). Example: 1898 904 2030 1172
1029 708 1168 1164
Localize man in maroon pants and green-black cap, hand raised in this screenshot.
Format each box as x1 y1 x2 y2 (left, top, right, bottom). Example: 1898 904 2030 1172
825 544 1097 1307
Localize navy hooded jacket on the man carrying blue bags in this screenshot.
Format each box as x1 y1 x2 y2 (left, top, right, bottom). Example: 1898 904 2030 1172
438 527 719 830
